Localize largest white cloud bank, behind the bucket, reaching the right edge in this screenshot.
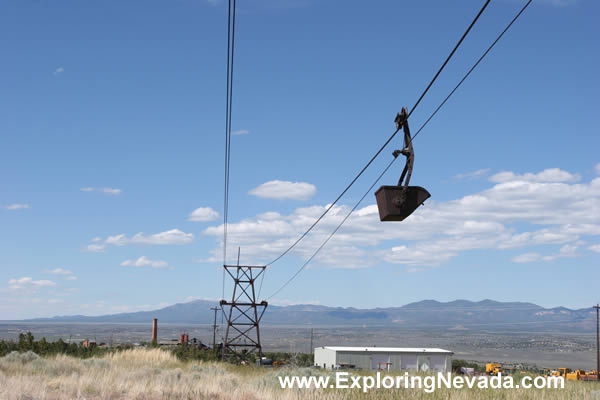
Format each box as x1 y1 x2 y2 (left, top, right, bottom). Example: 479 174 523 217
204 169 600 268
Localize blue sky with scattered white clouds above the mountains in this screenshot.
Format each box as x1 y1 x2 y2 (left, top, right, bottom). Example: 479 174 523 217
0 0 600 319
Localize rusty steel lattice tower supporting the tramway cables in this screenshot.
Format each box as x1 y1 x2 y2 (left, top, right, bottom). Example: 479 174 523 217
220 265 268 361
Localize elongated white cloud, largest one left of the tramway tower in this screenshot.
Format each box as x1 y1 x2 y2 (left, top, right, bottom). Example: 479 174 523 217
83 229 194 253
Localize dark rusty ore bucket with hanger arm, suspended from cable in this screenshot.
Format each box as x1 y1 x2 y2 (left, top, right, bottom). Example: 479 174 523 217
375 108 431 221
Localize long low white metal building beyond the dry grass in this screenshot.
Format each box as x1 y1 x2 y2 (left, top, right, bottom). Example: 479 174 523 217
315 346 454 372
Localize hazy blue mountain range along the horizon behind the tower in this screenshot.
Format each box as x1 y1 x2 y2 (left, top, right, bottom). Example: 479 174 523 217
28 300 596 332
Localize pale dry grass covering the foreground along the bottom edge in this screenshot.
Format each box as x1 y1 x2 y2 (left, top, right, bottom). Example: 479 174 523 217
0 349 600 400
